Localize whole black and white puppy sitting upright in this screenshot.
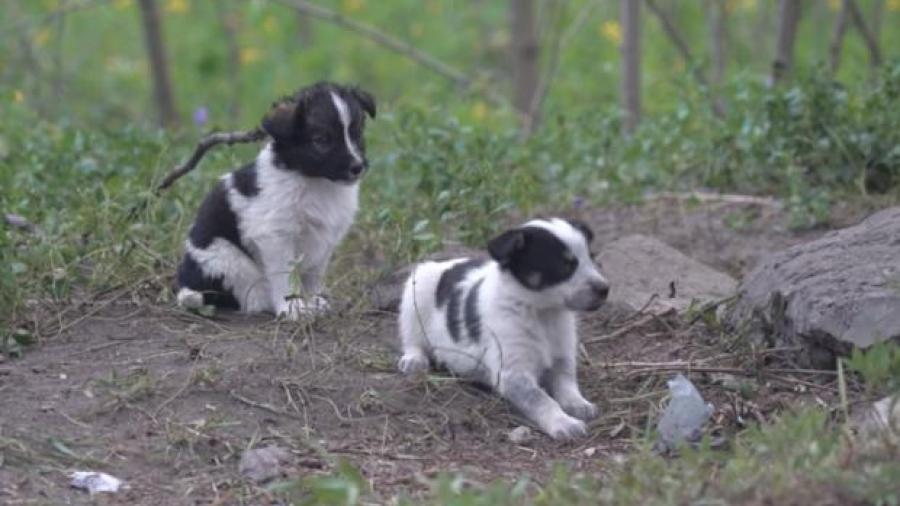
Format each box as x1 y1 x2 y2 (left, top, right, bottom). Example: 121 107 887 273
177 82 375 319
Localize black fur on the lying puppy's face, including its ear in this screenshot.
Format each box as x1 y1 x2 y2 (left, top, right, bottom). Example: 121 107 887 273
488 227 578 290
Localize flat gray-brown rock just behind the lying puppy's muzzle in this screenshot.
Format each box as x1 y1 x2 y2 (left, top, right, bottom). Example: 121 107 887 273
600 235 737 314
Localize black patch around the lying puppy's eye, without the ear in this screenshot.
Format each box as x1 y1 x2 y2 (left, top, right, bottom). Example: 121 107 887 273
505 227 578 290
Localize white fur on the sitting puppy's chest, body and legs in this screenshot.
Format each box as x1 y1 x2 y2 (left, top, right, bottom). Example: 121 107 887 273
178 145 359 319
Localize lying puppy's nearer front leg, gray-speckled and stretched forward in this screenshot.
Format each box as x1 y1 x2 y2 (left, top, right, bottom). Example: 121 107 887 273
498 372 587 439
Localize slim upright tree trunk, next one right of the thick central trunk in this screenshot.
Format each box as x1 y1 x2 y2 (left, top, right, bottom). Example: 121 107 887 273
619 0 641 134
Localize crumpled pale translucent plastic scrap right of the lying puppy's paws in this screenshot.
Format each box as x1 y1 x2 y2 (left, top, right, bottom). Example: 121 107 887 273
657 374 713 452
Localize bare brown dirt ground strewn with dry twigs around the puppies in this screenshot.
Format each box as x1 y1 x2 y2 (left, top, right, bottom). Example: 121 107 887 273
0 198 852 504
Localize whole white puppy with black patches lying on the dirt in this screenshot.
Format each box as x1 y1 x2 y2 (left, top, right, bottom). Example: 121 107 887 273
399 218 609 439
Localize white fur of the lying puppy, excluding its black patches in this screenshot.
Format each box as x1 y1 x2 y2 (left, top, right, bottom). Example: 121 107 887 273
399 219 606 439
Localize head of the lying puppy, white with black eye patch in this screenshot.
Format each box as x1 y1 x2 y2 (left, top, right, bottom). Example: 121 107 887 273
488 218 609 311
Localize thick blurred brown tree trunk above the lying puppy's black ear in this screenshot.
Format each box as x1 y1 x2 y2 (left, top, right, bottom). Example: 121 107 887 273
509 0 539 120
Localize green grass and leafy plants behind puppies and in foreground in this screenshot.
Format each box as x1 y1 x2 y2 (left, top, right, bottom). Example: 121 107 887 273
0 0 900 505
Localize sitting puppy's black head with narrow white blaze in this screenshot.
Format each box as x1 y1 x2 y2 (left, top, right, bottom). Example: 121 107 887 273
262 82 375 183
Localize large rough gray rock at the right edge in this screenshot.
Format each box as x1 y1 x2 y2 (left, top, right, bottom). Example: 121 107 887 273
725 207 900 368
